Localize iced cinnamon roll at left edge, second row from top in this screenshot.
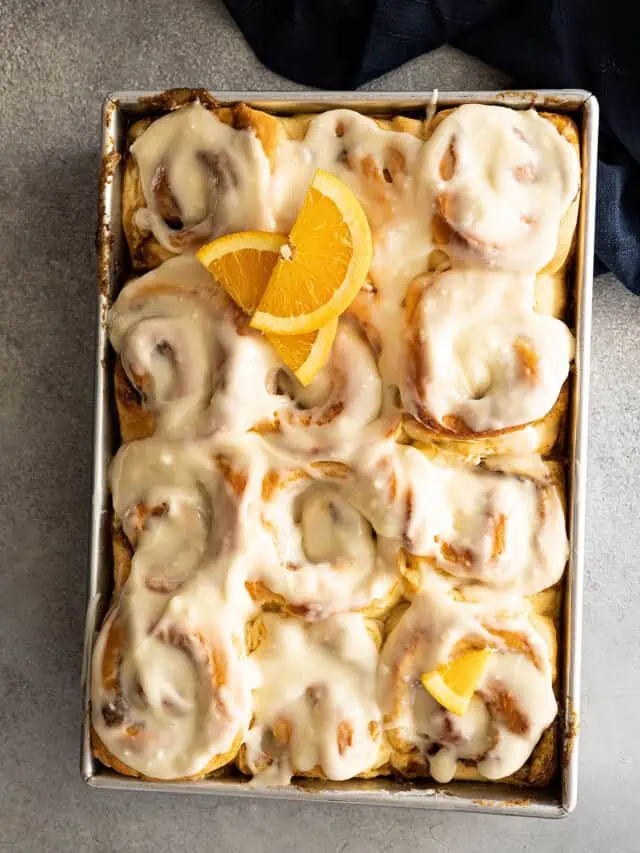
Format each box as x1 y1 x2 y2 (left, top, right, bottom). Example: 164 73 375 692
109 256 282 441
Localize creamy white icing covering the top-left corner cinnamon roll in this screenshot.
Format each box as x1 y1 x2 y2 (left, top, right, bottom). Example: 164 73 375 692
131 103 274 252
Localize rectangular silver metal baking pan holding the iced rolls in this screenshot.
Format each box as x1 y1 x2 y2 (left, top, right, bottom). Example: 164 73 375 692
81 90 598 817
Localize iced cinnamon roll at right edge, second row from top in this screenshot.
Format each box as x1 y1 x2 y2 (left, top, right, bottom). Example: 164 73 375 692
402 270 574 450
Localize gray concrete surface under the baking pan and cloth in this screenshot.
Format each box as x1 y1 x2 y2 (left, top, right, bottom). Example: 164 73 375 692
0 0 640 853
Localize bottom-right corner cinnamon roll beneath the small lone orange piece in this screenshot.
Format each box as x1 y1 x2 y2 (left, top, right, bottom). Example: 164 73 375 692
378 593 556 784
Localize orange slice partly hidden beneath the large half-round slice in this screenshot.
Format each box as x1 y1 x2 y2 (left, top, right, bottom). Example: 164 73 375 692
197 231 338 385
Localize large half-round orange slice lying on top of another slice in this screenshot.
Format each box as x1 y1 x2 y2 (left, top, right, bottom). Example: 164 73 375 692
251 169 373 335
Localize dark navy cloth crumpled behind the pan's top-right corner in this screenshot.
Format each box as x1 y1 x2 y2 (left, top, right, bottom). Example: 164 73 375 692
225 0 640 293
